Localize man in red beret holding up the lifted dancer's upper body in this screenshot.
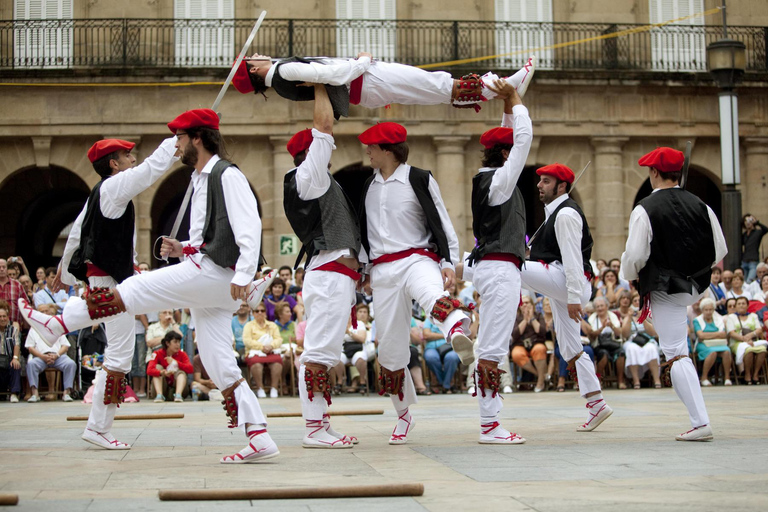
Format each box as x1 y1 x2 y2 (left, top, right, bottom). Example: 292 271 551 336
283 85 360 448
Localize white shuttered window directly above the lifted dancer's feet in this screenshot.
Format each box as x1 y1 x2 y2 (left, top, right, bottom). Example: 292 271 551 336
495 0 554 69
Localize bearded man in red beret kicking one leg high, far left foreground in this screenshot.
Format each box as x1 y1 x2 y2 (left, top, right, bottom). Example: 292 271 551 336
23 109 280 464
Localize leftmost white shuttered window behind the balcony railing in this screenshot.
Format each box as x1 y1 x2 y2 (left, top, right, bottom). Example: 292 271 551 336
13 0 72 68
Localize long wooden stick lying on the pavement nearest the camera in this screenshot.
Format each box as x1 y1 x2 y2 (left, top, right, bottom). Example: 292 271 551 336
158 483 424 501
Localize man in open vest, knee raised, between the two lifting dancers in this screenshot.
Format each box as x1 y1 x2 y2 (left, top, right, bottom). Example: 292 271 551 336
358 123 472 444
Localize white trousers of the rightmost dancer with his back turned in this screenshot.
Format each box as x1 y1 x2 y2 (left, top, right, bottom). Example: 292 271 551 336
651 292 709 428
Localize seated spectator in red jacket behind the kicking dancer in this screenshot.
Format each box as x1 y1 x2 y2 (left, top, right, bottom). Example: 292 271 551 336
147 331 195 402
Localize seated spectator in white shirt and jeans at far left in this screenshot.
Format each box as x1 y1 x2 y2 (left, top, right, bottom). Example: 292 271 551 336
24 306 77 403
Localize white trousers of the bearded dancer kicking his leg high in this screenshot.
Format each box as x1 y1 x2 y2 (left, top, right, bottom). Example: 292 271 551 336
117 256 267 427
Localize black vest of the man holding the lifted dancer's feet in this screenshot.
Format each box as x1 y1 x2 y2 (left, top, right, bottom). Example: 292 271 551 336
470 170 525 261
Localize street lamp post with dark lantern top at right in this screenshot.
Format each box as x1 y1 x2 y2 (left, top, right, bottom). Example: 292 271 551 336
707 30 746 269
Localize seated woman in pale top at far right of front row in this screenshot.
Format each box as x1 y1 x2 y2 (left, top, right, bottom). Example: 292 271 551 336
726 294 767 385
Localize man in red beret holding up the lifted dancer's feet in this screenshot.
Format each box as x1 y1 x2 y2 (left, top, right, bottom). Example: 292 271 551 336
464 80 532 444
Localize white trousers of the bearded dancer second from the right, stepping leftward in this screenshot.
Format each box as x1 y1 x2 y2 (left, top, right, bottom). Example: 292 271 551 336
521 261 600 396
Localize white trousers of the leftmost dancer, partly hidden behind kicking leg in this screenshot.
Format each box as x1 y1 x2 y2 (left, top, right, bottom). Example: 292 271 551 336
86 276 136 432
